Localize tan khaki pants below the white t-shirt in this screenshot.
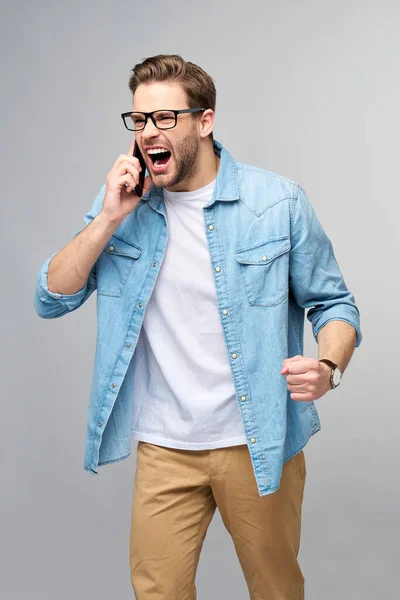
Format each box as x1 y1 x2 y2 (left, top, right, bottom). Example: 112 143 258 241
130 442 306 600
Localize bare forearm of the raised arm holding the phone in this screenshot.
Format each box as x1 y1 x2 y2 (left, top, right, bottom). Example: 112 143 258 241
47 212 119 294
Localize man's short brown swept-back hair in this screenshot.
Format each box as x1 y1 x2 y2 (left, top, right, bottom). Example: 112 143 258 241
129 54 217 141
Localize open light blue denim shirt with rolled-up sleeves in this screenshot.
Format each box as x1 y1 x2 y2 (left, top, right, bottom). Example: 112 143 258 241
34 141 361 496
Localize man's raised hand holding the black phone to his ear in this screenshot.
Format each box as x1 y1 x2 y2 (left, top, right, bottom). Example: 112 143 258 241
100 140 151 222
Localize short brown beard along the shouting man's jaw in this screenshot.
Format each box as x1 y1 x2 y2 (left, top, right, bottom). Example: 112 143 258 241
150 127 200 187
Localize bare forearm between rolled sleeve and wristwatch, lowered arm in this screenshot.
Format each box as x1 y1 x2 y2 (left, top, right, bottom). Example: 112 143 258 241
318 321 356 373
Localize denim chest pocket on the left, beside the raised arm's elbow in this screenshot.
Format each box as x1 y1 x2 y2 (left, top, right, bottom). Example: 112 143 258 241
96 235 142 298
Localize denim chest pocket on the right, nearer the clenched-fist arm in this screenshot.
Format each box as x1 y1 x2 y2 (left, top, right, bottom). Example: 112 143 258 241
235 236 291 306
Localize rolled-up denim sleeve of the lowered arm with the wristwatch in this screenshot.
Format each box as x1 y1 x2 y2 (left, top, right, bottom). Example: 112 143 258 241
289 186 362 347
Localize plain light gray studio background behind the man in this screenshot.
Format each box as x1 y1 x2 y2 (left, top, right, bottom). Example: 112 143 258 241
0 0 400 600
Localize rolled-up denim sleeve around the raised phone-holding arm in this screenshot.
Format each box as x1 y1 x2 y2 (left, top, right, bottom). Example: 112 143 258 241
34 185 105 319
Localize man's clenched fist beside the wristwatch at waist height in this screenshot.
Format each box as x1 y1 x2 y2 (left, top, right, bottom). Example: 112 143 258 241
281 355 331 402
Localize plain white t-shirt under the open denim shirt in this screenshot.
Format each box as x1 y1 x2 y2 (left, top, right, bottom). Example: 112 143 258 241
132 180 246 450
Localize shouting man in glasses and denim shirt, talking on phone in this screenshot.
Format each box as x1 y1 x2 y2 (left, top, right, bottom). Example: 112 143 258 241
35 55 361 600
